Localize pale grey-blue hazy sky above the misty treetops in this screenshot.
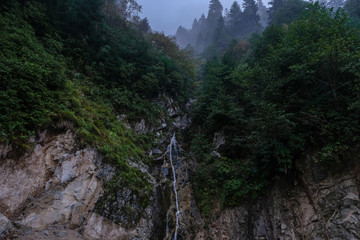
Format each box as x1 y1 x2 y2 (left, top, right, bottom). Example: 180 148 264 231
137 0 270 35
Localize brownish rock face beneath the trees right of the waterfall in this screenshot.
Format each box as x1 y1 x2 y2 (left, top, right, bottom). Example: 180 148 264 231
196 159 360 240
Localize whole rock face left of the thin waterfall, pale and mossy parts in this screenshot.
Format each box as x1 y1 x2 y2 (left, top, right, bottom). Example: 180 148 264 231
0 98 188 240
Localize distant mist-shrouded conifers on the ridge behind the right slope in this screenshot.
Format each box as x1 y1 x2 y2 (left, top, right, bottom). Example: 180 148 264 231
175 0 359 59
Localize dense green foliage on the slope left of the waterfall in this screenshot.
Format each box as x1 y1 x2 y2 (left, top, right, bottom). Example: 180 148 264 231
0 0 194 210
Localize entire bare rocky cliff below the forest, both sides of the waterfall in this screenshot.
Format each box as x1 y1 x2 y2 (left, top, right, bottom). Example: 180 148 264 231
0 102 360 240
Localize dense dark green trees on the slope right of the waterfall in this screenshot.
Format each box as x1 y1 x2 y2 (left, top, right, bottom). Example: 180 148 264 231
192 4 360 212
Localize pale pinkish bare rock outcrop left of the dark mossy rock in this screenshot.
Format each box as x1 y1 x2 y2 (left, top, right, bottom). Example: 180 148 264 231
0 131 150 239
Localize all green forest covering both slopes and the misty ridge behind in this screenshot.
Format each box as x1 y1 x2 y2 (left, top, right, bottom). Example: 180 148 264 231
0 0 360 221
